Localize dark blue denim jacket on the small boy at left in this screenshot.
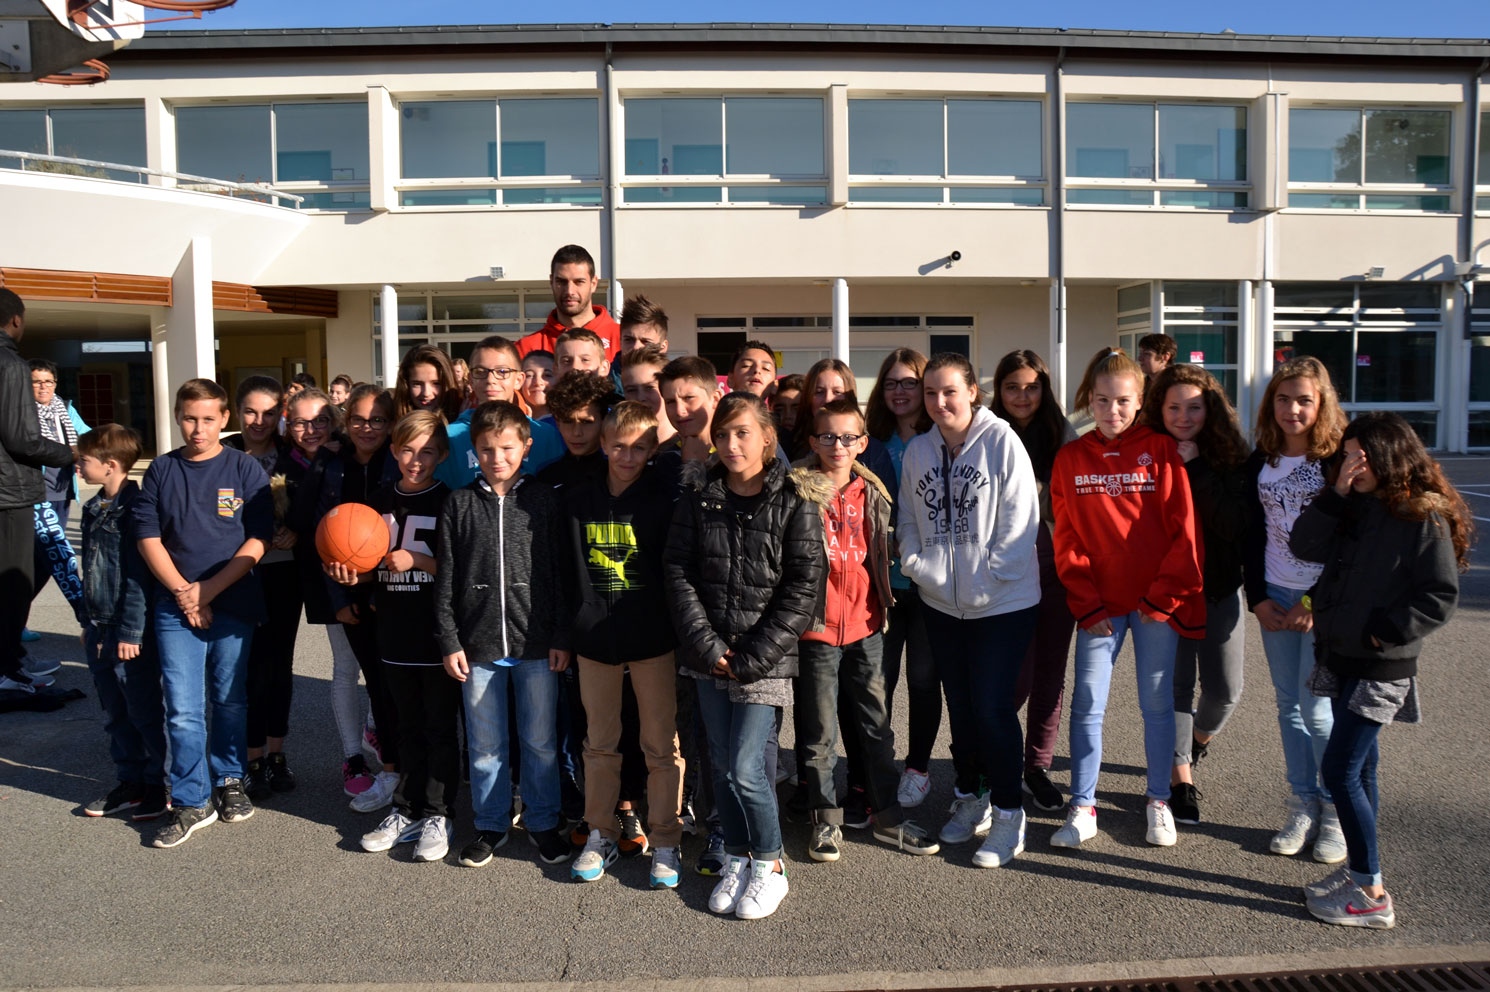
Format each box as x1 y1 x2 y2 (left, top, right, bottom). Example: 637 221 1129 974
82 480 155 643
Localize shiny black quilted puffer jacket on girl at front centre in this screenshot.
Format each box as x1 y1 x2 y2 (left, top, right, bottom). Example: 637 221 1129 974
663 459 827 684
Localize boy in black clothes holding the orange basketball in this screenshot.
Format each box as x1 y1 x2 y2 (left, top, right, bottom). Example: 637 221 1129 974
342 410 460 861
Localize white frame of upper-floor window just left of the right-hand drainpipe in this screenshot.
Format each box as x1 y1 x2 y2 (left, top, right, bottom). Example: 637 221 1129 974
845 92 1050 210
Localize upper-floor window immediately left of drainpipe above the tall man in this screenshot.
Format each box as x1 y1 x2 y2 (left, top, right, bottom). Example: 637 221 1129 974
398 97 600 207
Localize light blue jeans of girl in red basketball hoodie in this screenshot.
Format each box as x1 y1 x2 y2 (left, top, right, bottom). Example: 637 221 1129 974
1071 611 1180 806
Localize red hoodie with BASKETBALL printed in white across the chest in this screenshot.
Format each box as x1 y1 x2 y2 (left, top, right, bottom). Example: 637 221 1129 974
1050 427 1205 639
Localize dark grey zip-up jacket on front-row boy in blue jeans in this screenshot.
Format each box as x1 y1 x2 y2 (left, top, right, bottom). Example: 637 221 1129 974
435 475 572 664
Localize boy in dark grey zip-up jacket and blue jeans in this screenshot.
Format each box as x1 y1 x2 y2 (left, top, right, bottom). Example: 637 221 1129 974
435 401 572 868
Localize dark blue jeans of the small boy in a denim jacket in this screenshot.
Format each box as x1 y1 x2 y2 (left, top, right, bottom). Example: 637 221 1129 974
83 624 165 788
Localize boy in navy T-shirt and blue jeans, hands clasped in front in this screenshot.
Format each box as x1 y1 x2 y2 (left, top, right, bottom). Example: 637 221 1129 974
134 378 274 848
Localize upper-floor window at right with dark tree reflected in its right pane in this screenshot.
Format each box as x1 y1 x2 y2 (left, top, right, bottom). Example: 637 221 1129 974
1289 107 1453 210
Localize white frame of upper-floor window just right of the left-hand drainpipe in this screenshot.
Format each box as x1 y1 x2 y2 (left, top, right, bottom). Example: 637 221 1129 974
615 89 833 210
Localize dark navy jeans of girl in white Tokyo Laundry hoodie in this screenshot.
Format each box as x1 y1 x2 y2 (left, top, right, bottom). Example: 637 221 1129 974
924 606 1040 809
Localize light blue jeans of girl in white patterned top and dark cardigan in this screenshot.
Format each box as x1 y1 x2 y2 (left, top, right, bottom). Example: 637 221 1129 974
1262 582 1335 803
